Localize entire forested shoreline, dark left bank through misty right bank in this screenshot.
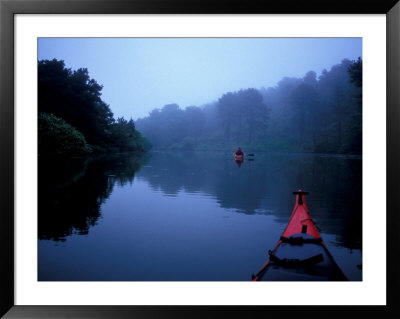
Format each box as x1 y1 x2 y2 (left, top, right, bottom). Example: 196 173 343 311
38 58 362 156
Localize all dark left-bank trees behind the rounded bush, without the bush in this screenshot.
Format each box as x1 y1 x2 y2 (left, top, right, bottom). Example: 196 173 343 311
38 59 151 157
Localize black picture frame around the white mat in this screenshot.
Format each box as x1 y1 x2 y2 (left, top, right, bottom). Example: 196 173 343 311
0 0 400 318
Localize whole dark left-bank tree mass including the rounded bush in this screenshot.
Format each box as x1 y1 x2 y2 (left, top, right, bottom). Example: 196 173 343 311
38 59 150 155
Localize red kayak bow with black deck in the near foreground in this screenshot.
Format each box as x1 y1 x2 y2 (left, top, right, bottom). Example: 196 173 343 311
252 190 347 281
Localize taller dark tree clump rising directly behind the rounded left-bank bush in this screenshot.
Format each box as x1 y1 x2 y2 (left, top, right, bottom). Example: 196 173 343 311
38 60 114 145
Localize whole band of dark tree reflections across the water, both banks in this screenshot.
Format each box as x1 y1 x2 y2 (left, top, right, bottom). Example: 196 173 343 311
39 152 362 249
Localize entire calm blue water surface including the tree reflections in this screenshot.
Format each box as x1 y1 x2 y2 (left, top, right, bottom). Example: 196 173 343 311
38 152 362 281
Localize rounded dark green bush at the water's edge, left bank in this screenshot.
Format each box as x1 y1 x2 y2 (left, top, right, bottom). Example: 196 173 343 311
38 112 92 155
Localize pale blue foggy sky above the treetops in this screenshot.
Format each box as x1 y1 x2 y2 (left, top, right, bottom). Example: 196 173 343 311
38 38 362 120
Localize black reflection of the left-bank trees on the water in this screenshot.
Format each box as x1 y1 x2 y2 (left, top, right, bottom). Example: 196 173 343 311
38 154 149 241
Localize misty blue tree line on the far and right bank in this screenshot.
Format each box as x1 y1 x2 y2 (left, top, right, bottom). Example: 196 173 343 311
136 58 362 154
